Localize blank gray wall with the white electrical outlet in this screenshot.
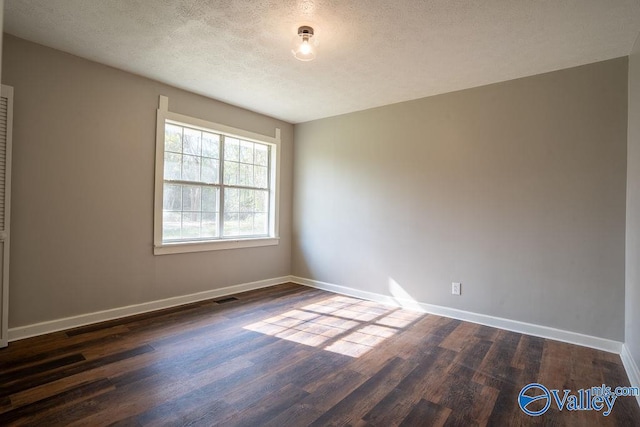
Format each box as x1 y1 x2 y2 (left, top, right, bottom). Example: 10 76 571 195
292 58 637 341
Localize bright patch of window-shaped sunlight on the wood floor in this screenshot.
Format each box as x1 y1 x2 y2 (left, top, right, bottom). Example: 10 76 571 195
245 296 423 357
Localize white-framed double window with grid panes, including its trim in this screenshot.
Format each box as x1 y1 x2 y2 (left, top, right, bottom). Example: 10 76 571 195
154 96 280 255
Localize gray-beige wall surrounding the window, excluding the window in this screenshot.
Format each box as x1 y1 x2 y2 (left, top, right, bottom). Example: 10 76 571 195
2 35 293 327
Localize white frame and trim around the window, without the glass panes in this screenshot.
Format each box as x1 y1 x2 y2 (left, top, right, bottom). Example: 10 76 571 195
153 95 280 255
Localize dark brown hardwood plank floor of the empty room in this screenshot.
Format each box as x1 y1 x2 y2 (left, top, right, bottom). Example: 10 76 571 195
0 284 640 427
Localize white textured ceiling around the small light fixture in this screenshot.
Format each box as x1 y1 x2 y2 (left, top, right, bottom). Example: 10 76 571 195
4 0 640 123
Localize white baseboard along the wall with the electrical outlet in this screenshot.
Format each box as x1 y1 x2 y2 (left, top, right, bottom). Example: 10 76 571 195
290 276 622 354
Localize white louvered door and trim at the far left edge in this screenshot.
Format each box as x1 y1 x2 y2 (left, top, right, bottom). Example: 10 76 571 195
0 85 13 347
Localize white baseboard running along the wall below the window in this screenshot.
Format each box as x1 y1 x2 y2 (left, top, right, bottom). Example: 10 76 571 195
9 276 290 341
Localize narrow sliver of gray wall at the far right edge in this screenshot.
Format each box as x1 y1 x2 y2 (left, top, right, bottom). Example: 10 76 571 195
625 38 640 366
